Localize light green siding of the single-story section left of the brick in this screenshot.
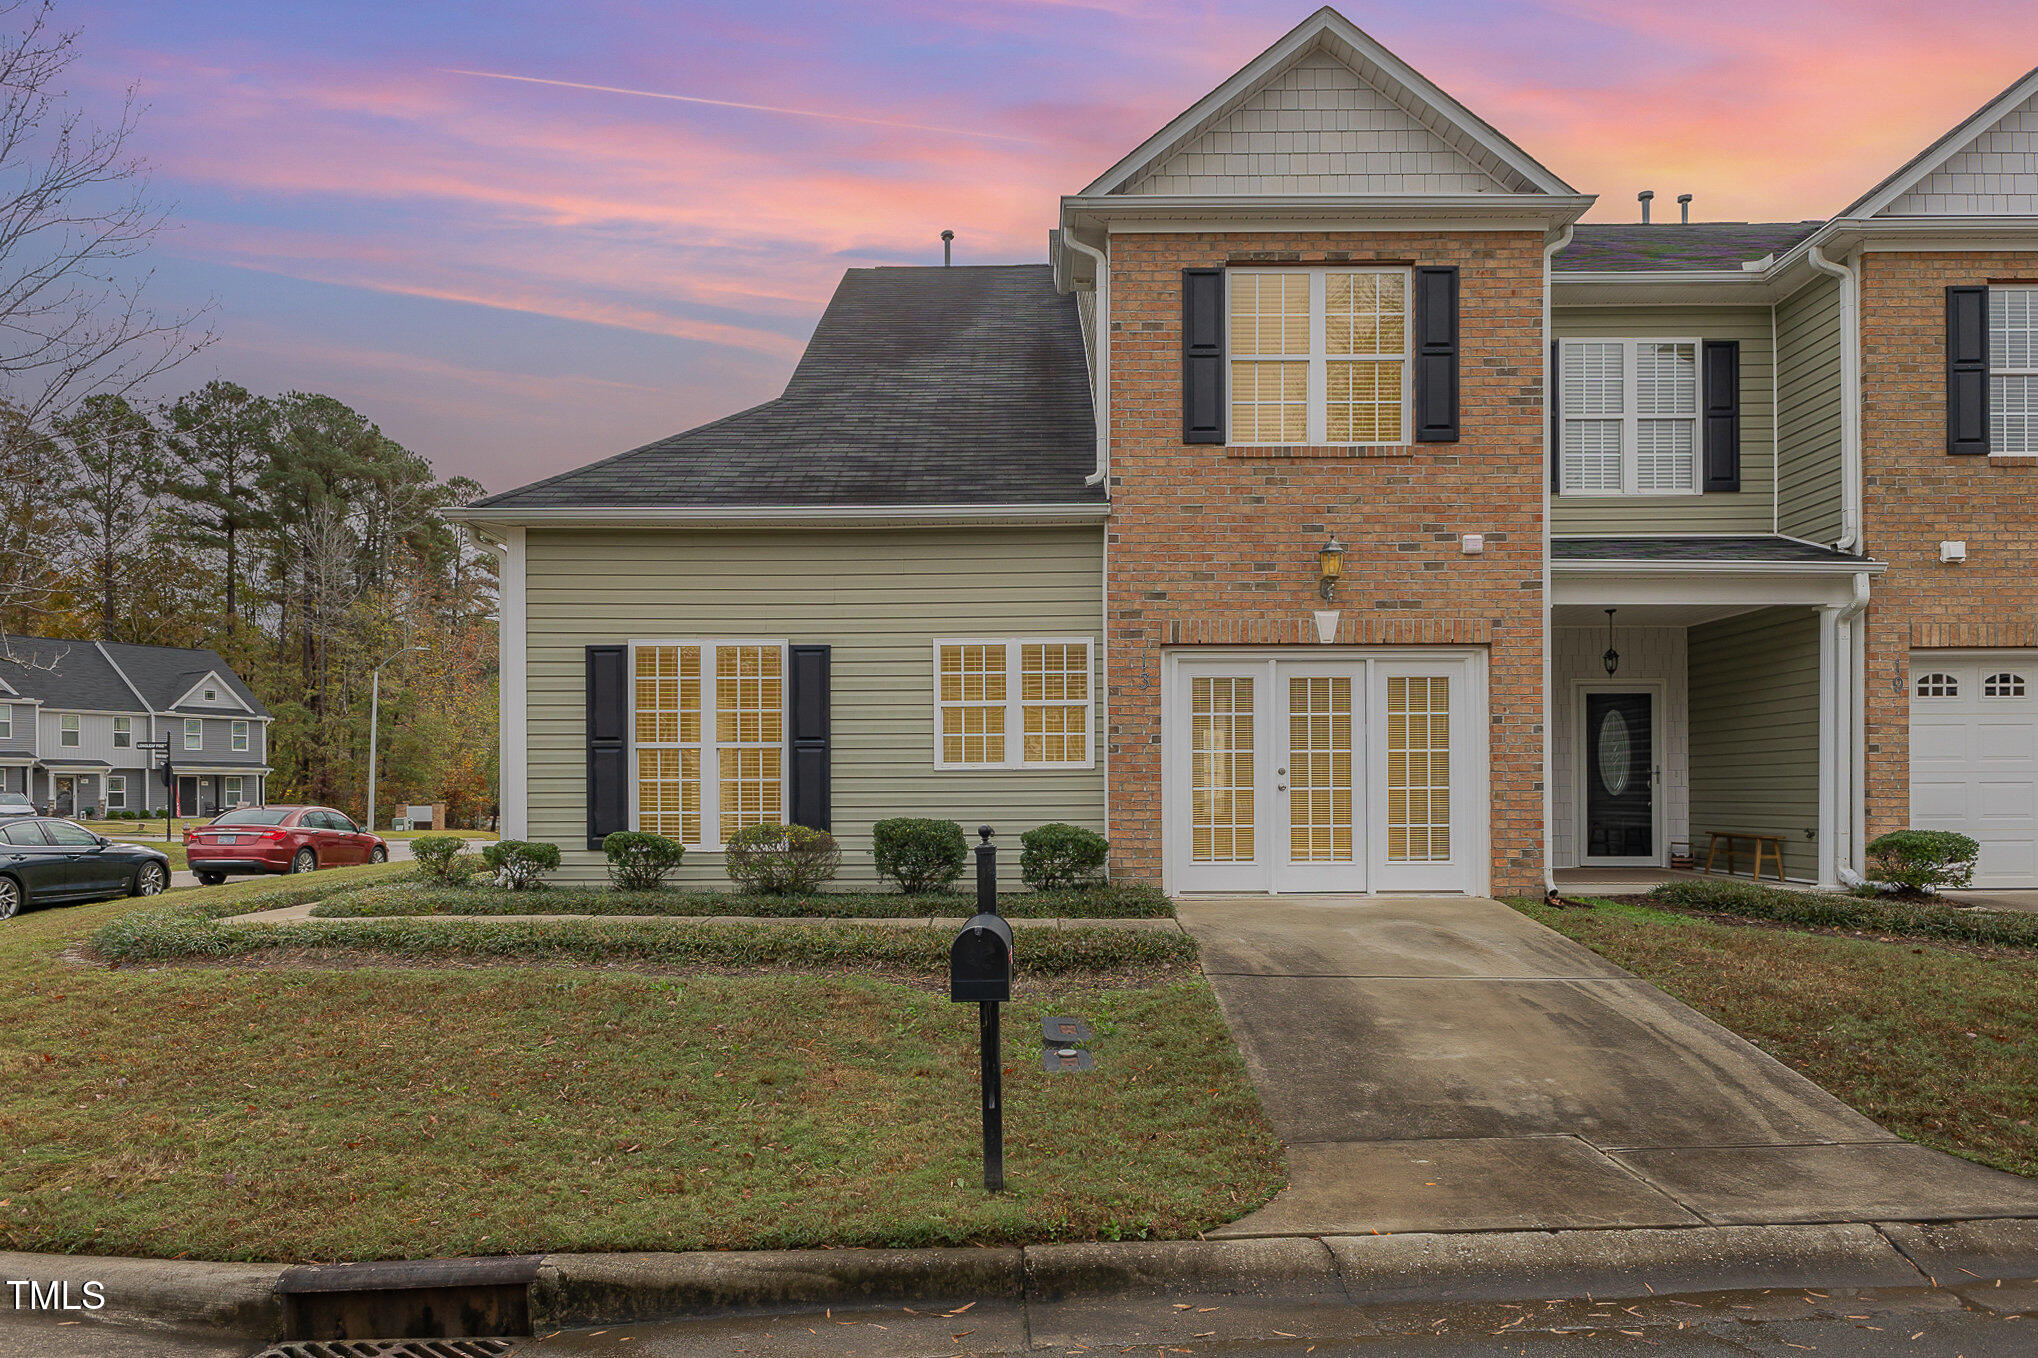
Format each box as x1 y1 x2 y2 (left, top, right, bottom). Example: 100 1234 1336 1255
526 526 1105 885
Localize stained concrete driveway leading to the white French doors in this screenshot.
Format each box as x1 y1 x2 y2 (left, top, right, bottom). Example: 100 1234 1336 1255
1176 897 2038 1236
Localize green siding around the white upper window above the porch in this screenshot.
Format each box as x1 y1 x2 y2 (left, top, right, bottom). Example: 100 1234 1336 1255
1551 306 1775 534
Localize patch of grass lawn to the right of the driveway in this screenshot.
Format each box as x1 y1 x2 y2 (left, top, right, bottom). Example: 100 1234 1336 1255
1514 901 2038 1174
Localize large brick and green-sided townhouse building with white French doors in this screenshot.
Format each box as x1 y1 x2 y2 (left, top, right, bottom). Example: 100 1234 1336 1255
459 10 2038 891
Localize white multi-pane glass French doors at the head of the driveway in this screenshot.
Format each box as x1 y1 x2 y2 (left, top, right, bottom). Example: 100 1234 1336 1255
1164 655 1484 891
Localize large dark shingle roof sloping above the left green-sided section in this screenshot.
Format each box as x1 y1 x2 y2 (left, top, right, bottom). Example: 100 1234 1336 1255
473 265 1103 510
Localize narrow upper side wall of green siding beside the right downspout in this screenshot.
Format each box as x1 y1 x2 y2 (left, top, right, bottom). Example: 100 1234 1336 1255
1777 275 1842 542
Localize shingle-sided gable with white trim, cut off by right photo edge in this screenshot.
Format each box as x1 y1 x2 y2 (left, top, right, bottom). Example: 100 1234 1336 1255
1840 69 2038 216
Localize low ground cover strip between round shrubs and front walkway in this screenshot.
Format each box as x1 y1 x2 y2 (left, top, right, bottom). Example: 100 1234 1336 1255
316 881 1174 920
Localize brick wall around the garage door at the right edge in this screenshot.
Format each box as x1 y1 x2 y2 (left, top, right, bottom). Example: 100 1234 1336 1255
1861 251 2038 838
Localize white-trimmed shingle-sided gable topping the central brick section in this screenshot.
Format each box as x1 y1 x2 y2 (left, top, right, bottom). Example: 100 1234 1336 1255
1082 8 1575 198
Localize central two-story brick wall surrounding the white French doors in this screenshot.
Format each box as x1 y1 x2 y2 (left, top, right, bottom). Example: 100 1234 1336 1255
1105 230 1547 891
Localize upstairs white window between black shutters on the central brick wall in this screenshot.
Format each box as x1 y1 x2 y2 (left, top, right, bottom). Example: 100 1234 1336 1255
1225 269 1408 445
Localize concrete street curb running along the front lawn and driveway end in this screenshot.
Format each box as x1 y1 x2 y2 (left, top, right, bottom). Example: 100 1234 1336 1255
0 1217 2038 1342
